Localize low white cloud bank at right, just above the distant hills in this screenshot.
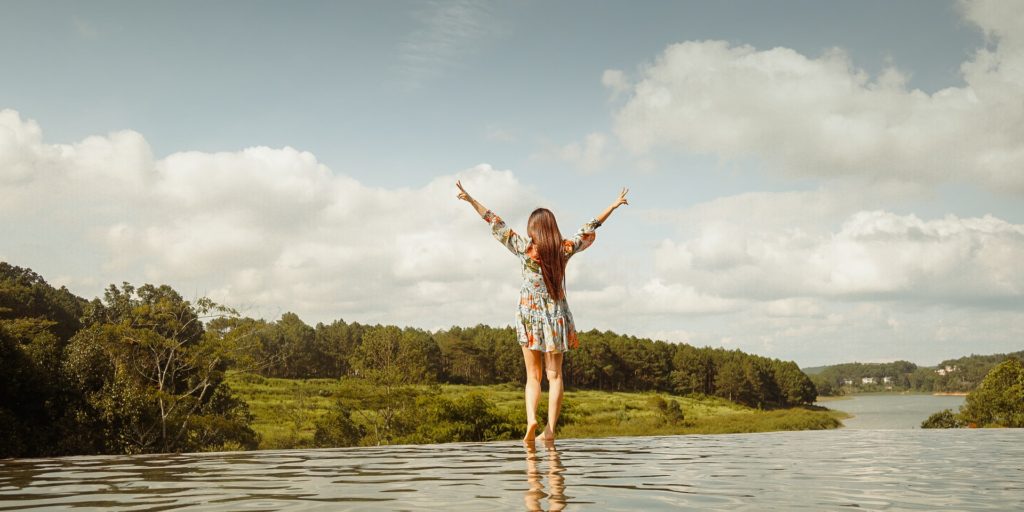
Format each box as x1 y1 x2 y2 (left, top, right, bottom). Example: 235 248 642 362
655 206 1024 307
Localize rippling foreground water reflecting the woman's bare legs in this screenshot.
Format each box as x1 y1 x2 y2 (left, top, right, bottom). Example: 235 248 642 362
0 429 1024 511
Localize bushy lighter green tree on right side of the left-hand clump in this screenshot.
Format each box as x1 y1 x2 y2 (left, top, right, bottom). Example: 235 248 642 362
63 284 257 454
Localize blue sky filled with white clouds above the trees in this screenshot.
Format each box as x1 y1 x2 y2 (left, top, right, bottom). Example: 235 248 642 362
0 0 1024 367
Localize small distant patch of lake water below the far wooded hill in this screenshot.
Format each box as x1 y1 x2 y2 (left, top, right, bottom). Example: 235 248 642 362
817 393 966 429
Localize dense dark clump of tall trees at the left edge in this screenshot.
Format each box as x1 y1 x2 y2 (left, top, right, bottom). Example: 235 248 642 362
0 263 257 456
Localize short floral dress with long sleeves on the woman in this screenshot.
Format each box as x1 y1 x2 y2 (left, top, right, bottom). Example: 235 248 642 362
483 210 601 352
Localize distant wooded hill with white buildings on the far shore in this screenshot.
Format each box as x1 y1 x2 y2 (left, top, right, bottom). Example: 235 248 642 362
806 350 1024 396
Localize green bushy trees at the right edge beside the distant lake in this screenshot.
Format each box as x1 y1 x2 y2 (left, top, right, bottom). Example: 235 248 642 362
921 357 1024 428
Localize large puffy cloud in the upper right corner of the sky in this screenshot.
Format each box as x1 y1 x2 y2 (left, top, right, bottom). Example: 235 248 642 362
612 2 1024 194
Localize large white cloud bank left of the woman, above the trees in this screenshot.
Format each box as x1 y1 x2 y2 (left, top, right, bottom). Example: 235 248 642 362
0 111 542 328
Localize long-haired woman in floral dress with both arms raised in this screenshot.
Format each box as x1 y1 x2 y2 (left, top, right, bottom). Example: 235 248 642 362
456 181 629 442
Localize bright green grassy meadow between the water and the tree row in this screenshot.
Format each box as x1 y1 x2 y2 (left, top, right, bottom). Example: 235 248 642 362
227 373 845 449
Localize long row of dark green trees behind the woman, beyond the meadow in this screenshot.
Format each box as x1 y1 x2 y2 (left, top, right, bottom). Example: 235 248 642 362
216 313 817 408
